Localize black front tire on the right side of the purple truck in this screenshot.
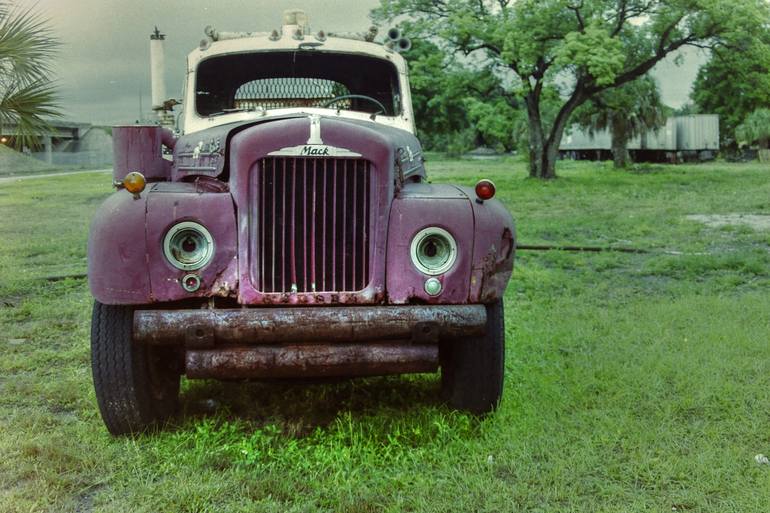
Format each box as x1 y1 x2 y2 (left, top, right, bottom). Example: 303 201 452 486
439 299 505 415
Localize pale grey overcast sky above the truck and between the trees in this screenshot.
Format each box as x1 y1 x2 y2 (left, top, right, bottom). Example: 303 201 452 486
19 0 703 124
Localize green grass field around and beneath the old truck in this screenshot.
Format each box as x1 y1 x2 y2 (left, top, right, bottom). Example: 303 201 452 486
0 159 770 513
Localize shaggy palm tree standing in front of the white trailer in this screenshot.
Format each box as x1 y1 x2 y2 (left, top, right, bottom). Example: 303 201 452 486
575 75 668 168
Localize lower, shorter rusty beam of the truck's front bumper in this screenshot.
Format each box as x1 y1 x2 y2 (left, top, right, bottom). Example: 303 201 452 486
185 344 438 379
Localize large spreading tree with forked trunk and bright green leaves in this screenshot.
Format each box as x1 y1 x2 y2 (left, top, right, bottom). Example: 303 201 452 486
372 0 767 178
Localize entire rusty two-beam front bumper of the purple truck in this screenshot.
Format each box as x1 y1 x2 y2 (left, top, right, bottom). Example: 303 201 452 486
129 305 486 379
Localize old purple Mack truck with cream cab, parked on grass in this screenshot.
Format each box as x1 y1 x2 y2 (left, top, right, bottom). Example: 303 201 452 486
88 10 515 435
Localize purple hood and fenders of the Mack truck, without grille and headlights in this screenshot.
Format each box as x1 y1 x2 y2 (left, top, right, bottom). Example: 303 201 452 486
88 116 515 306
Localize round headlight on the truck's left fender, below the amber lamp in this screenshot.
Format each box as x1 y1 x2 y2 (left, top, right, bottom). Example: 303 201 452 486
163 221 214 271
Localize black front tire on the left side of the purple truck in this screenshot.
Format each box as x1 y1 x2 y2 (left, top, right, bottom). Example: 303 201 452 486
91 301 180 435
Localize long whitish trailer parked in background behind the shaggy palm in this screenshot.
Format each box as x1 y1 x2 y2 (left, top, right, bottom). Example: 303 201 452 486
559 114 719 162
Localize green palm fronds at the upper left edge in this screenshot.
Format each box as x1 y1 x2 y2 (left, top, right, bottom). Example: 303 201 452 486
0 0 61 148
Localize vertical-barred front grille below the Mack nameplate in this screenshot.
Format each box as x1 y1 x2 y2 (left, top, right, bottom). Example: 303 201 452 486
255 157 371 293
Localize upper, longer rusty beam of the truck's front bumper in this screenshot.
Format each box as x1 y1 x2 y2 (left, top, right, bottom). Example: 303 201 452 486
134 305 480 347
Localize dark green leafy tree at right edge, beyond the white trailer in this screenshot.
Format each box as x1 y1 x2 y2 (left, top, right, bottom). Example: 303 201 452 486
690 32 770 146
